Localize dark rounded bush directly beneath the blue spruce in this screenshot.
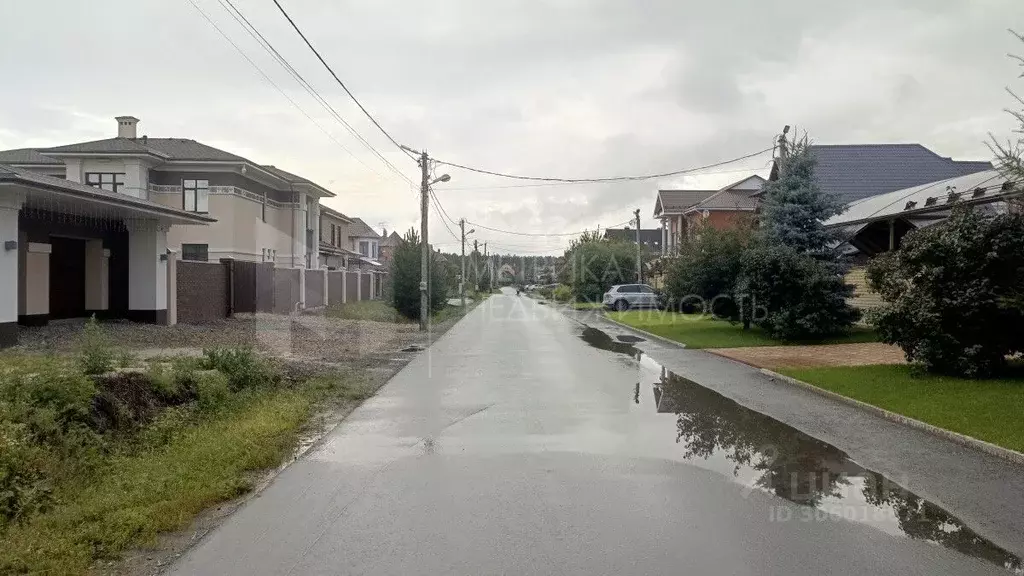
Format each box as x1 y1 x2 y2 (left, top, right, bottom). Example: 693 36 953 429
736 243 860 340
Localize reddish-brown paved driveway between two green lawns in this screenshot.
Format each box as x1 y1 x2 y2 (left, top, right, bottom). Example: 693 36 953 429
705 342 906 370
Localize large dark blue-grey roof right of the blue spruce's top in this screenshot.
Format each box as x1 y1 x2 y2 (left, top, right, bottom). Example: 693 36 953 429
770 143 992 204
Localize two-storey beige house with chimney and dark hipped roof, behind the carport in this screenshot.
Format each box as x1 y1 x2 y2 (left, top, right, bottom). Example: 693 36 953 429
0 116 334 268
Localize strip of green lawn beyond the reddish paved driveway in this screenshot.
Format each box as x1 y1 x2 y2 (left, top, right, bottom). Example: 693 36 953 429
607 311 878 348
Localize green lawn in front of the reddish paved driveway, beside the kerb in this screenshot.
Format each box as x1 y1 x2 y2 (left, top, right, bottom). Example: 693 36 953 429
780 365 1024 452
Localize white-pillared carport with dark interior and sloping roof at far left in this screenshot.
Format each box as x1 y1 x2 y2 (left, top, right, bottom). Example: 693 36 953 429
0 165 215 346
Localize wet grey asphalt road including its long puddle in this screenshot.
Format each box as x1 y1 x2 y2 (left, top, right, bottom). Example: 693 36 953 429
171 293 1021 575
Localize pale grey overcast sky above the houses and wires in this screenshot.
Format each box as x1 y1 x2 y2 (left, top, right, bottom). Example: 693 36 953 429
0 0 1024 253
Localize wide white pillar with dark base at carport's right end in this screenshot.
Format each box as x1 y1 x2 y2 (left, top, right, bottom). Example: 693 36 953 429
126 220 168 325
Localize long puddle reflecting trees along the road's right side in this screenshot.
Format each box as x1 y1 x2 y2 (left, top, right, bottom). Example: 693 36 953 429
580 327 1024 574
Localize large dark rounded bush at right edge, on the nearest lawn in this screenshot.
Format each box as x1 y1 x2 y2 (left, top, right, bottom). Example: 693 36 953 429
867 208 1024 377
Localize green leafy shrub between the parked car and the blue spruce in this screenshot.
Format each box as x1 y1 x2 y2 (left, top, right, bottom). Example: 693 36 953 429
666 222 751 319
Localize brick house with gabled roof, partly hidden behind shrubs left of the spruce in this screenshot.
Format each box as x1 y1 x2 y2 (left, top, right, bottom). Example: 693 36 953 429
654 175 765 254
